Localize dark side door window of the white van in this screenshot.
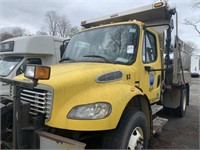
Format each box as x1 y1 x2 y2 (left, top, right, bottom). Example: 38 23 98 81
16 58 42 76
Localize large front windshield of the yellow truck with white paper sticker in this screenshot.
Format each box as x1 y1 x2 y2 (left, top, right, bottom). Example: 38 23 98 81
63 24 139 64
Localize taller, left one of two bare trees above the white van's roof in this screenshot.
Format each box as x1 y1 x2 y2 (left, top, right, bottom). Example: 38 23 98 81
45 10 59 36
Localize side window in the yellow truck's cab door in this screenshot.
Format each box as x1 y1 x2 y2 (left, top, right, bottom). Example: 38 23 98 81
142 31 157 63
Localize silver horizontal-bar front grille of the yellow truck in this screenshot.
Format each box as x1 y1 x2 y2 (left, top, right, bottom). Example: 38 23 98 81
20 89 53 120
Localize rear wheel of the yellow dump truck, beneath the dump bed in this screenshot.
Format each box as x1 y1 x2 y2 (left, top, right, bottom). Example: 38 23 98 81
176 88 188 117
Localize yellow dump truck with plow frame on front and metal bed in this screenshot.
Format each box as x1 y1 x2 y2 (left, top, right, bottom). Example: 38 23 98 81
0 1 190 149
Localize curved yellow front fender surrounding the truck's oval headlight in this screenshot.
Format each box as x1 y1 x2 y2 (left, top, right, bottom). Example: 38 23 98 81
46 83 148 131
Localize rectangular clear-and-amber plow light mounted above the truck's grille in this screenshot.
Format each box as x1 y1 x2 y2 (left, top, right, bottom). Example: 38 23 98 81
24 65 51 80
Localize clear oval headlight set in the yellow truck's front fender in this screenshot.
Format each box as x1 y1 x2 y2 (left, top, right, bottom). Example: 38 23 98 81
67 102 112 120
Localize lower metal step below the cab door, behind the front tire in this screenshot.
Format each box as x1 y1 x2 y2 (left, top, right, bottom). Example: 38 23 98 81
153 117 168 134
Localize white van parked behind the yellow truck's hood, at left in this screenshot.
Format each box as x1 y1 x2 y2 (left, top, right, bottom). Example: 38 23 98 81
0 36 65 97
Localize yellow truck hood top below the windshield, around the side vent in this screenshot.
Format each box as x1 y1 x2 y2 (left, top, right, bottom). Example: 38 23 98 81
30 62 135 91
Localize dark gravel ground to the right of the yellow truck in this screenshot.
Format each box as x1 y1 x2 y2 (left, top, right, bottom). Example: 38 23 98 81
149 78 200 149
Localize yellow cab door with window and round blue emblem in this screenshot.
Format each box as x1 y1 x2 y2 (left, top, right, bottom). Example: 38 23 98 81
140 30 161 103
